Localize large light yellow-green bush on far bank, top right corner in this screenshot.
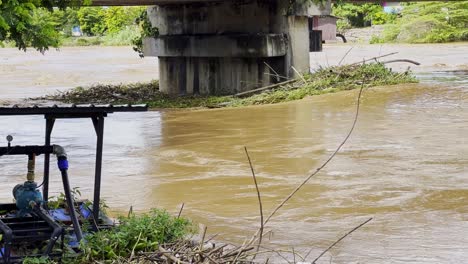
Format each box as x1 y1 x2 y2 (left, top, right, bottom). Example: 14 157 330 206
372 1 468 43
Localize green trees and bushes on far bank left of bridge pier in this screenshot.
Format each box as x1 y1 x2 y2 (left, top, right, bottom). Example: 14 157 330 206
0 1 146 52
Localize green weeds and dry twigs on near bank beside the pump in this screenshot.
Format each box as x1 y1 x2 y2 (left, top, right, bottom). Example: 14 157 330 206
23 209 264 264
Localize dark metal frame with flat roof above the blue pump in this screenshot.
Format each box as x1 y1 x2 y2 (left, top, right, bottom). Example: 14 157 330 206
0 105 148 230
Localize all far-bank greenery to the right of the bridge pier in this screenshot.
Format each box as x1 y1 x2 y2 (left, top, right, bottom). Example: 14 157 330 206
333 1 468 43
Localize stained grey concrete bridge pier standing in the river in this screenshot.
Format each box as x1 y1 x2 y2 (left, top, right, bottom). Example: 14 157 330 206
144 0 330 95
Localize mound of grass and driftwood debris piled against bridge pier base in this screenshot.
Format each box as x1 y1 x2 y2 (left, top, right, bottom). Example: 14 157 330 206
41 63 417 108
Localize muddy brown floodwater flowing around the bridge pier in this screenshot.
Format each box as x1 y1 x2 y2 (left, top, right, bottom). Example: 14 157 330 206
0 44 468 263
